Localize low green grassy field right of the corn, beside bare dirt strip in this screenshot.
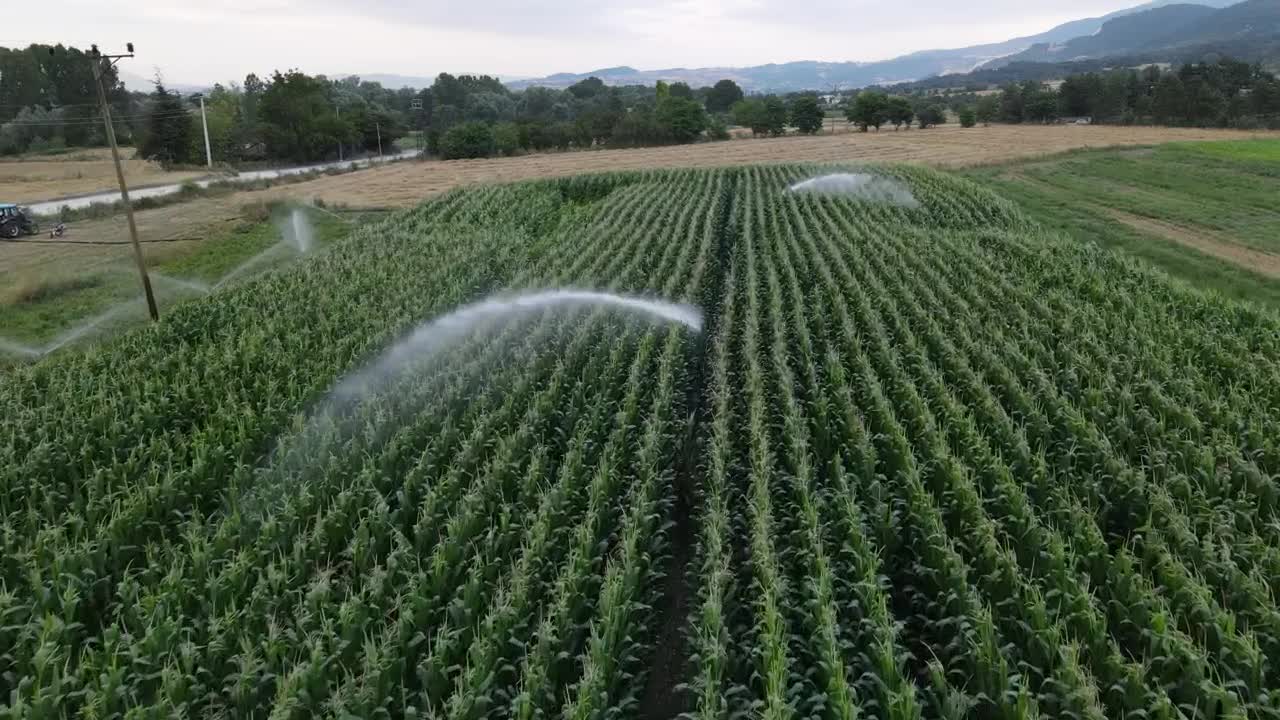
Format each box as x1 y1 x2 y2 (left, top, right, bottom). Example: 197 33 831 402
963 140 1280 309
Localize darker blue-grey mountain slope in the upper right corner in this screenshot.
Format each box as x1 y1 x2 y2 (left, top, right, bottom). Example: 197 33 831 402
997 0 1280 64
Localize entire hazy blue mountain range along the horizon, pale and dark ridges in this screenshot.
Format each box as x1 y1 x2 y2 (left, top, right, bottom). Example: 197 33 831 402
507 0 1280 92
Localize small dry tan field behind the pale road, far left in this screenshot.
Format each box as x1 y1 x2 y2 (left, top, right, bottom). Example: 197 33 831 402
0 147 209 204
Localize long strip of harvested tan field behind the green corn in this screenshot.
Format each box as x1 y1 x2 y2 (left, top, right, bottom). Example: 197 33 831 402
252 126 1280 208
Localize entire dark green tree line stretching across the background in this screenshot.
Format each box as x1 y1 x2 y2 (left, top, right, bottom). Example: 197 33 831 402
0 45 1280 164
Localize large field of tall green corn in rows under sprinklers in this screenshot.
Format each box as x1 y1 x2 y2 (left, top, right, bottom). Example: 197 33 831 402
0 165 1280 720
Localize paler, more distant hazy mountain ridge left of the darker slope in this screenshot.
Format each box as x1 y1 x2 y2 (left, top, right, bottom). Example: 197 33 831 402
507 0 1239 92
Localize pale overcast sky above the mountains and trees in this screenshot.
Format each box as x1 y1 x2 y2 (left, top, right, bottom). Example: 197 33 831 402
20 0 1140 85
